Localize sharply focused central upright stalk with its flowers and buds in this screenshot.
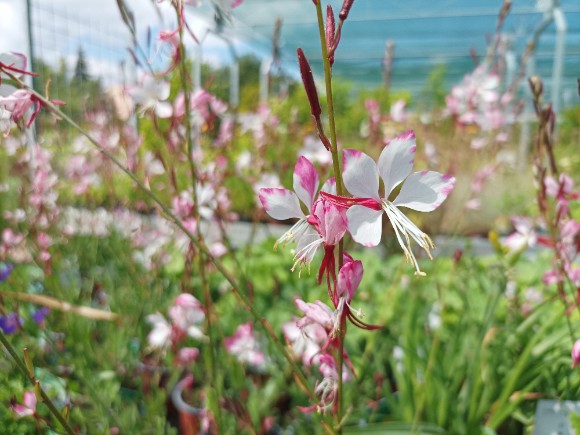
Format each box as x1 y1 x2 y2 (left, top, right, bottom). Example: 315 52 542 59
260 0 455 432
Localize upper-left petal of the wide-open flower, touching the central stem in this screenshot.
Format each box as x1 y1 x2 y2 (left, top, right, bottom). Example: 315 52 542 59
342 148 380 200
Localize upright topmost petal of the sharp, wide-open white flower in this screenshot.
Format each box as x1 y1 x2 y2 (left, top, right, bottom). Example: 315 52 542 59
378 130 417 198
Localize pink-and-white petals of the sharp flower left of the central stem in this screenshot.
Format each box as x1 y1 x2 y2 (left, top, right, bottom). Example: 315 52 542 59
258 156 335 249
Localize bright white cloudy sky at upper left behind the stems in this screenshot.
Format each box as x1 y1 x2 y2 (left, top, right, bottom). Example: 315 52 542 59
0 0 280 83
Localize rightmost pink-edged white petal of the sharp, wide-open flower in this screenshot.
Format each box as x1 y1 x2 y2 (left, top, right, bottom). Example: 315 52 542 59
393 171 455 212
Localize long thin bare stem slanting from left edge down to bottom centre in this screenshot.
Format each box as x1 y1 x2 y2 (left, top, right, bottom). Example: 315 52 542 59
3 70 334 433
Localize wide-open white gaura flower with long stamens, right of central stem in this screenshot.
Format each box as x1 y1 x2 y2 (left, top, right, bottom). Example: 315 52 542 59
321 130 455 275
